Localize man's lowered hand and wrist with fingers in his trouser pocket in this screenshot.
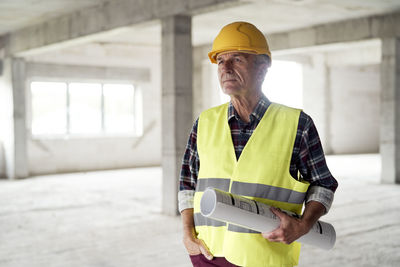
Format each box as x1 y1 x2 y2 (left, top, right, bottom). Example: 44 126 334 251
181 209 213 260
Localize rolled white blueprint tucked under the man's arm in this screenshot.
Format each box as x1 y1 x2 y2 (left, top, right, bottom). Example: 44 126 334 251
200 187 336 250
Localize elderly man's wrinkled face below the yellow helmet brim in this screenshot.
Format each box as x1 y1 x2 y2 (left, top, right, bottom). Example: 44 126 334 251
217 52 260 96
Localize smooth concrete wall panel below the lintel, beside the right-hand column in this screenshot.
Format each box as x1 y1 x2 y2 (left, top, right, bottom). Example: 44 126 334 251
330 65 380 154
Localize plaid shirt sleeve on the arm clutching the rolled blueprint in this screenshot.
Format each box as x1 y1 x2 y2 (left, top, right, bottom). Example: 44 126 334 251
291 112 338 215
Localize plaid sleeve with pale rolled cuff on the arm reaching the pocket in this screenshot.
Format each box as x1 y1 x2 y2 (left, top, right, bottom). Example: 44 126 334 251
178 119 200 212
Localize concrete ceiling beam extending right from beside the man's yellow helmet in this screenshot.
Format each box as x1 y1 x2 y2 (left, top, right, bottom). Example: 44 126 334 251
267 12 400 50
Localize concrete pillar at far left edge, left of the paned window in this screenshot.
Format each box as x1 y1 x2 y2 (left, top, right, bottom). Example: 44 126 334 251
0 58 28 179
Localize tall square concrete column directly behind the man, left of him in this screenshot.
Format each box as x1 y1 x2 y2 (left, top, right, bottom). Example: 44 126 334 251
161 15 193 215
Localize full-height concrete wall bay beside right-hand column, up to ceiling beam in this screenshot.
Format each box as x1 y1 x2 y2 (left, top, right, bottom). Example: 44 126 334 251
326 40 381 154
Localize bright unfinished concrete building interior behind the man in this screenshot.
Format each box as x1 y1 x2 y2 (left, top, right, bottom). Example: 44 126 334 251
0 0 400 267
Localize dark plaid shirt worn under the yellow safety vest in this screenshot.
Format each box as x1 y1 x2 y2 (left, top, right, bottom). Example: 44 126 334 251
178 96 338 215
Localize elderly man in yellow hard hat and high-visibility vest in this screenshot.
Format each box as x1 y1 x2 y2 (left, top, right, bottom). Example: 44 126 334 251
178 22 338 266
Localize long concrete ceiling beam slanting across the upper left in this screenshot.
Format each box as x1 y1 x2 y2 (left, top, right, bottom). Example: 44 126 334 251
0 0 240 56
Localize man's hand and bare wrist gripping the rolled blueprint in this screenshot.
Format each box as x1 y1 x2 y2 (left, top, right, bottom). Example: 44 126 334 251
262 201 325 244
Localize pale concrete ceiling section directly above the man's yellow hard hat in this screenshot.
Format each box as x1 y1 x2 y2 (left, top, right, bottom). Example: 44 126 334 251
193 0 400 44
